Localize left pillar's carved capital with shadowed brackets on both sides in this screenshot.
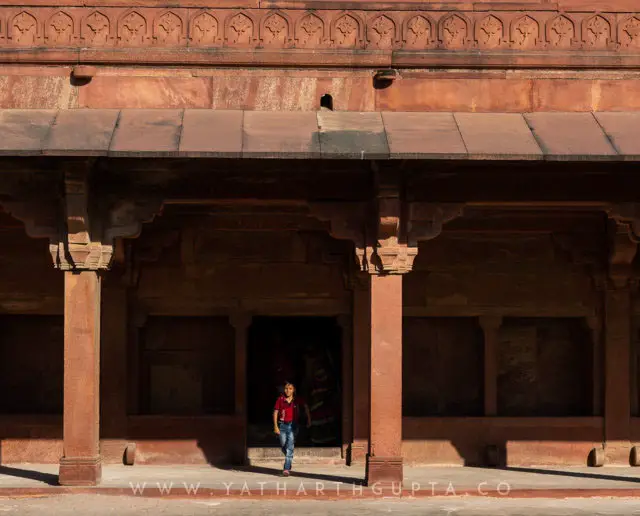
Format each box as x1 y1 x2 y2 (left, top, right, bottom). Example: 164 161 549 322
0 166 163 271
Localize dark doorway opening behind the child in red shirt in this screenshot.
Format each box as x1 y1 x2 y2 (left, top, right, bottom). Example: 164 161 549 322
247 317 342 447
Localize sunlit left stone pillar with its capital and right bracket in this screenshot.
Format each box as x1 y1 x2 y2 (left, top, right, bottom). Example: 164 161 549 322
49 165 162 486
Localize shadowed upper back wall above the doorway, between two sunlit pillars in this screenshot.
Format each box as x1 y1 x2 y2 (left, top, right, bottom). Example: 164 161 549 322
134 223 350 315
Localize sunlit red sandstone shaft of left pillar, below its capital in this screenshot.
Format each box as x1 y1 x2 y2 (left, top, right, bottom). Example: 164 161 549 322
59 271 102 485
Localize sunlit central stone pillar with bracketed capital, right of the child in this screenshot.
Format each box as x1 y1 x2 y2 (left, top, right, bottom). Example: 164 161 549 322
310 190 463 485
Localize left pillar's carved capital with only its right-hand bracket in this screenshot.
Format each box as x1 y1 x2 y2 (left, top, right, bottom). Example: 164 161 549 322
50 163 162 270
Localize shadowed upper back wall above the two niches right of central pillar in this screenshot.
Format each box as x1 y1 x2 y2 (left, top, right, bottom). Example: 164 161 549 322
404 232 597 317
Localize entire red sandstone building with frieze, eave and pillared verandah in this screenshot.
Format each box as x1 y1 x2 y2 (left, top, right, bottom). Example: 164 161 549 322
0 0 640 485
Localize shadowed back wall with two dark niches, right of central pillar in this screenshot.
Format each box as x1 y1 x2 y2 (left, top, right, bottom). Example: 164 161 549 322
403 232 603 464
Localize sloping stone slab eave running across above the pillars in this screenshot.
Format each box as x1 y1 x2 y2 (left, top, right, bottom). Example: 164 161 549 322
0 109 640 161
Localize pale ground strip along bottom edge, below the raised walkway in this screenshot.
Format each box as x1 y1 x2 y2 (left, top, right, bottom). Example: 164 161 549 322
0 494 640 516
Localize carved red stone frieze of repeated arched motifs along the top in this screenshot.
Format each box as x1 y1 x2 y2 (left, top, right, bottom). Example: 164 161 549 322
0 5 640 53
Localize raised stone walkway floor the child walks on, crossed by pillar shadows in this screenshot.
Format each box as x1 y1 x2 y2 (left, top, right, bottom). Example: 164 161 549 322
0 463 640 498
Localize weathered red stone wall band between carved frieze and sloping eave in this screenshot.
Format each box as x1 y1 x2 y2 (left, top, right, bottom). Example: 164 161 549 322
5 65 640 112
